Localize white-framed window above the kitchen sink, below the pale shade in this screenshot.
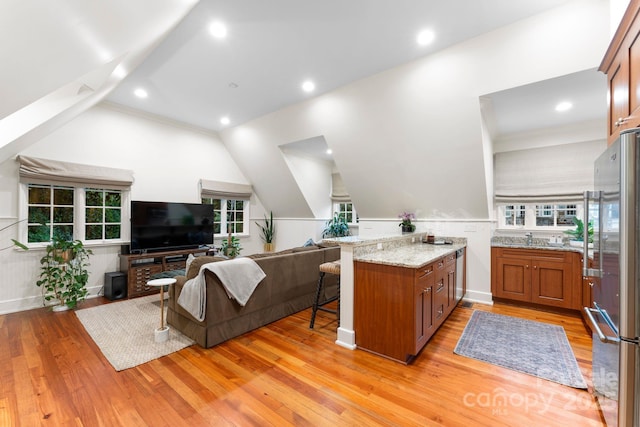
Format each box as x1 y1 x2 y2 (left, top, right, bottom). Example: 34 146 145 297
498 203 582 230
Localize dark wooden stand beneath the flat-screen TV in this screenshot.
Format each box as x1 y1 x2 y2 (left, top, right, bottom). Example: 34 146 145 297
120 248 214 298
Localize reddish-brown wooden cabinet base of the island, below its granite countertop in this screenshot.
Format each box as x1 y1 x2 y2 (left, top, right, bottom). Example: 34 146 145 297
354 253 456 363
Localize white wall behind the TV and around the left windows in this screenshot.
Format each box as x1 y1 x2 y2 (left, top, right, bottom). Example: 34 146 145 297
0 104 264 313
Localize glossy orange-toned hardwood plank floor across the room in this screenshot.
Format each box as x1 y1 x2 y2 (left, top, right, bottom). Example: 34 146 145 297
0 299 603 427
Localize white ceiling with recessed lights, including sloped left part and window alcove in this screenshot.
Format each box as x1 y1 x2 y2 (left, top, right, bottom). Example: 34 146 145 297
0 0 606 166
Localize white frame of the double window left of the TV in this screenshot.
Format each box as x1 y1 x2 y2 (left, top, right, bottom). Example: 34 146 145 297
18 181 131 249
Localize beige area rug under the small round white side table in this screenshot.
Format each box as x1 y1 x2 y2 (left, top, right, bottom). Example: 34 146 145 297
76 295 194 371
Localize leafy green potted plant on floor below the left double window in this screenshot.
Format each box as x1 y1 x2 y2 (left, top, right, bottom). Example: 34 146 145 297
36 237 93 311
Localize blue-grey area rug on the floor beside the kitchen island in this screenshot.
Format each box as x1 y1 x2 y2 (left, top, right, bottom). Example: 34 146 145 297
454 310 587 389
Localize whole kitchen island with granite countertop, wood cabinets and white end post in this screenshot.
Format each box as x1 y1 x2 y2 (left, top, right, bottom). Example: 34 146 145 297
328 233 466 363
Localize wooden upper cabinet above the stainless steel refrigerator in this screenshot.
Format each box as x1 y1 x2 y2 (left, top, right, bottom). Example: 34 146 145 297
599 0 640 144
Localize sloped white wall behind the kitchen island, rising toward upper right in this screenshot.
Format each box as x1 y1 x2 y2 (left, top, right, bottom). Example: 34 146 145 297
221 0 609 308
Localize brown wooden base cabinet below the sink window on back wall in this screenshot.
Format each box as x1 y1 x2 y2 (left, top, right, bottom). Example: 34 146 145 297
491 248 582 310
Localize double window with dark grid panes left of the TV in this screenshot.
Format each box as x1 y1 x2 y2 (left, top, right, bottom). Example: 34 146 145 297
26 184 128 243
